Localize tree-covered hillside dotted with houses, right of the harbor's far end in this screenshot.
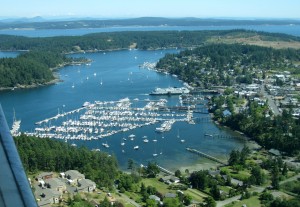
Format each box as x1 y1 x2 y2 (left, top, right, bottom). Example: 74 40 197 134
156 44 300 88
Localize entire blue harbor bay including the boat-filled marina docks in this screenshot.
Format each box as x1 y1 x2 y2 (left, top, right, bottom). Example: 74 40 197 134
1 50 244 171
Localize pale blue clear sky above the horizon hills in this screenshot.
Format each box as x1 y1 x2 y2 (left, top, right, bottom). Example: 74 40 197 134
0 0 300 19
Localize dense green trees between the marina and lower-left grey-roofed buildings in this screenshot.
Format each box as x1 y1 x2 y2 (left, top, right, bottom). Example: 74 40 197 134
15 135 118 187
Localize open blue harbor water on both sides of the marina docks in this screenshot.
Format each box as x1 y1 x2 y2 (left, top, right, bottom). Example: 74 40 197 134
0 50 244 170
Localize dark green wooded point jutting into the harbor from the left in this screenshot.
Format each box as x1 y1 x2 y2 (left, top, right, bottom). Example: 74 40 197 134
0 51 83 88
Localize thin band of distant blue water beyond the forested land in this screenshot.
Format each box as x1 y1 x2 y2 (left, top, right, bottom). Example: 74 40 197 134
0 25 300 37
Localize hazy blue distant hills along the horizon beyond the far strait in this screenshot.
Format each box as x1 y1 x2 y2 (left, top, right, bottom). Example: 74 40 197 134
0 17 300 29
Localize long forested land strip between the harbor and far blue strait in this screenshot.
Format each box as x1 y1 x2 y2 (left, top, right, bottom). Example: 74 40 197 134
0 30 300 53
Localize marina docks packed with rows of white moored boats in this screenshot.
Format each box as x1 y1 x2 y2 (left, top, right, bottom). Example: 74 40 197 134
26 98 194 142
